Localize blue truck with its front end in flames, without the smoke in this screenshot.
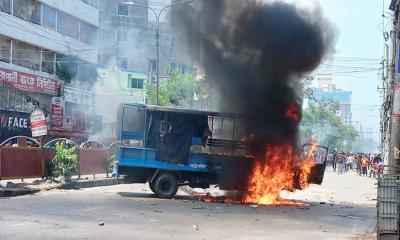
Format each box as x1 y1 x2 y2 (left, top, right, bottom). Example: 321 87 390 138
117 104 327 205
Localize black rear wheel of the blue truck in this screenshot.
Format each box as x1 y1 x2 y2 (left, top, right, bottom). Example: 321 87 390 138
153 173 178 199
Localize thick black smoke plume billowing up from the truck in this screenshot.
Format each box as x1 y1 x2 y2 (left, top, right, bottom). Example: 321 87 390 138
177 0 334 150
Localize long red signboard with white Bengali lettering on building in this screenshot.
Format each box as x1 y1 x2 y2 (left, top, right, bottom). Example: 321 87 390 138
0 68 58 95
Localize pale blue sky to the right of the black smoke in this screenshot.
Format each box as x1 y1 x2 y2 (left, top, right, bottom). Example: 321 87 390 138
287 0 391 141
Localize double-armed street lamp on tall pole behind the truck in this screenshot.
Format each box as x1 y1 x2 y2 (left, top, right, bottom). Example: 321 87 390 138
121 0 194 105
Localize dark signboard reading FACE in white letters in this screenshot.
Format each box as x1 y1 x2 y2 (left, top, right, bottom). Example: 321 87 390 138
0 110 31 143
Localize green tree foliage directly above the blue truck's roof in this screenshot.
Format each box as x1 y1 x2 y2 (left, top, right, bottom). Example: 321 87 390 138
146 69 209 109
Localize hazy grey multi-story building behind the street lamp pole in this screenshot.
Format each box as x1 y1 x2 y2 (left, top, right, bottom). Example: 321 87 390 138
99 0 196 78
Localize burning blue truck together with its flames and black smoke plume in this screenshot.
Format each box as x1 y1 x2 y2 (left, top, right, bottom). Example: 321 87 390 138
117 0 335 205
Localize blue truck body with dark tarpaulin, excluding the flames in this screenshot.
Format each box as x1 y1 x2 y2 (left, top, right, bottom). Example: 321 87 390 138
115 104 325 198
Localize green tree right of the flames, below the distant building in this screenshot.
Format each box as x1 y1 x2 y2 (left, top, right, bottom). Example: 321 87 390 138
300 101 358 151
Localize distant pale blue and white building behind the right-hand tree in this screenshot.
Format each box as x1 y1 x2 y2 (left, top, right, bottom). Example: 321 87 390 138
309 76 352 125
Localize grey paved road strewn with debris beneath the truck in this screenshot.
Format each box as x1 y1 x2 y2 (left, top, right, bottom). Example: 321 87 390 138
0 172 376 240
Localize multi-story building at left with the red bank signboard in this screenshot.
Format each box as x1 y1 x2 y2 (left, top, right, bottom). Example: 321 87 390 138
0 0 98 141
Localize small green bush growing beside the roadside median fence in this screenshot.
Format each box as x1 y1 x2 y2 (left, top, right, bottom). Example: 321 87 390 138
51 142 78 179
